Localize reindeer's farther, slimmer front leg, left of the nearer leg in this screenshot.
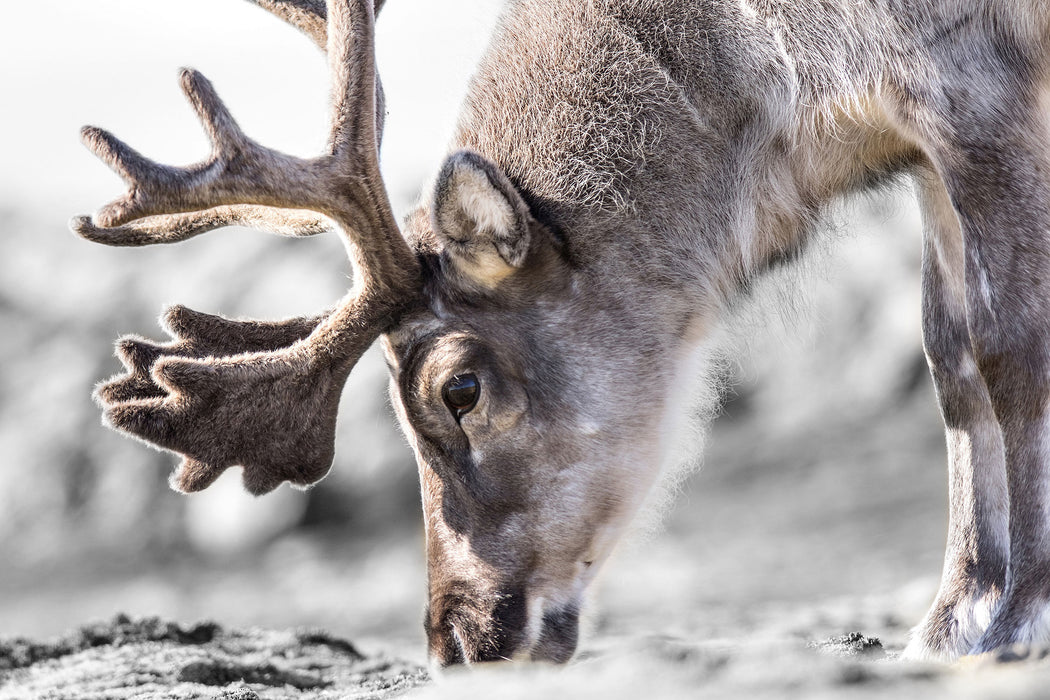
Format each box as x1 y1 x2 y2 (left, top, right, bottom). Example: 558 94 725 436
905 172 1009 661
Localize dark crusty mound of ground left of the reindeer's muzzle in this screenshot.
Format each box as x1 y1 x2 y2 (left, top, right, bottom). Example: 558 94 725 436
0 615 427 700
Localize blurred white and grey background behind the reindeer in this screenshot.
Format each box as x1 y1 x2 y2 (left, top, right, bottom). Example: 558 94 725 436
0 0 946 658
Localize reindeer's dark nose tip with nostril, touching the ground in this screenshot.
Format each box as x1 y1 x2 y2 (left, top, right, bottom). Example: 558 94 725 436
424 587 528 667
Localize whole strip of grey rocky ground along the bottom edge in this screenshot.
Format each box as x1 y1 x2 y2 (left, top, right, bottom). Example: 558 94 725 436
10 615 1050 700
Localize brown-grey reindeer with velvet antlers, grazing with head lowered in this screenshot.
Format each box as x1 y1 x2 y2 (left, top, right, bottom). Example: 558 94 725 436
71 0 1050 665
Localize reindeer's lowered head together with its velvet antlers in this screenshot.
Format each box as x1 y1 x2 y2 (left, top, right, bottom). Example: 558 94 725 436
72 0 680 664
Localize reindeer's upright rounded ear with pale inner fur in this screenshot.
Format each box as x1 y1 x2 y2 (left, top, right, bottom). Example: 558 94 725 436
433 151 533 287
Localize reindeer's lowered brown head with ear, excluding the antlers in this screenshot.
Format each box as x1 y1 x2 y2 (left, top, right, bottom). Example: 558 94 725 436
383 151 680 663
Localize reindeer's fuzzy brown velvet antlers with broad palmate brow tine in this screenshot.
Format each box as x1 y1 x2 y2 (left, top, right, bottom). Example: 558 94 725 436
74 0 421 493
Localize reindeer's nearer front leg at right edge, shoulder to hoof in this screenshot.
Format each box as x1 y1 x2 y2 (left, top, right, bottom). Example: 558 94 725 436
919 51 1050 653
